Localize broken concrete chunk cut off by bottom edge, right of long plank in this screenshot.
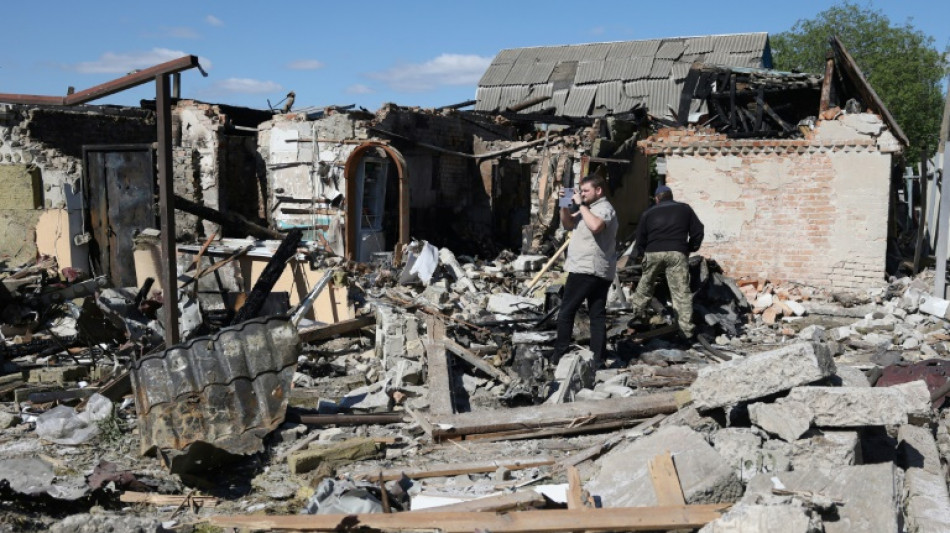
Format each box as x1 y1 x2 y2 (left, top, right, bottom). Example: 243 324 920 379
699 503 824 533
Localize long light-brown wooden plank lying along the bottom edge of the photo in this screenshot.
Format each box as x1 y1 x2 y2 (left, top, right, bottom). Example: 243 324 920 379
207 504 729 533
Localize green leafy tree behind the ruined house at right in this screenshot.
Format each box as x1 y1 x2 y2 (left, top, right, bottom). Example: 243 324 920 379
771 1 947 160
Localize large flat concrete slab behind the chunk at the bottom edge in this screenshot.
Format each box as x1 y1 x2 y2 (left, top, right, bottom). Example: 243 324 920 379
742 463 900 533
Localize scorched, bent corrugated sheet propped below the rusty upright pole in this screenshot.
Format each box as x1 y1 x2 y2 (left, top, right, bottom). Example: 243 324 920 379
130 317 300 468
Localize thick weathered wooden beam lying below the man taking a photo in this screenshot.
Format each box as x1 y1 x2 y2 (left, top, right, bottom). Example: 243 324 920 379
429 390 677 440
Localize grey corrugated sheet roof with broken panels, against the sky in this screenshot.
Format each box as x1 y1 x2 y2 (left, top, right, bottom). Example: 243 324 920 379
475 33 772 117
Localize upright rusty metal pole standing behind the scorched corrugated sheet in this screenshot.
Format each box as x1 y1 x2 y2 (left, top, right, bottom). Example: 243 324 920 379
155 74 180 342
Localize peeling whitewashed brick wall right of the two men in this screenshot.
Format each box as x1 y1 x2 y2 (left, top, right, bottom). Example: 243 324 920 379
642 117 891 289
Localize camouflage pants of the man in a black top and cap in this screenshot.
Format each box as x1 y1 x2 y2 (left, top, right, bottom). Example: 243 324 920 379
632 252 694 336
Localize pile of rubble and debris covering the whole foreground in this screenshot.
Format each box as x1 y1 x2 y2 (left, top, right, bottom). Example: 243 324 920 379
0 242 950 533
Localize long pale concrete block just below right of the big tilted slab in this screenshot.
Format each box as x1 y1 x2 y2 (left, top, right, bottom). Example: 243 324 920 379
788 380 930 427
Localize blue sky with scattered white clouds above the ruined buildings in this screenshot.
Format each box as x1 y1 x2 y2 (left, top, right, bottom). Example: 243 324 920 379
0 0 950 110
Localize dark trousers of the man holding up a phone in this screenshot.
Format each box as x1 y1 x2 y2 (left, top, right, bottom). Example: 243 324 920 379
554 272 611 361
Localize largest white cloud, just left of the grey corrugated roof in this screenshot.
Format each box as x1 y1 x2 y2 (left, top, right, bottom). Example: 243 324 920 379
367 54 491 92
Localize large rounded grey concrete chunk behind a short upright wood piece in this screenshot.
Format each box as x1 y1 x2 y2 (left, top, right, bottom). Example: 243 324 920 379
586 426 742 507
